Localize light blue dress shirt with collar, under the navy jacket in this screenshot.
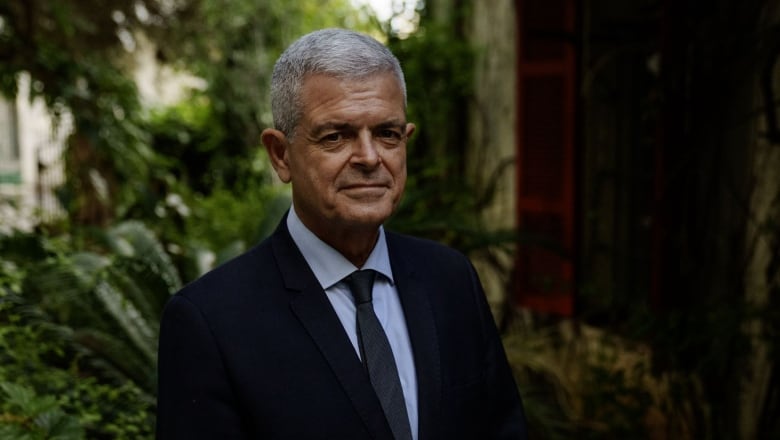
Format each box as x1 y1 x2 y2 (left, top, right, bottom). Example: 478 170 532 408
287 206 418 440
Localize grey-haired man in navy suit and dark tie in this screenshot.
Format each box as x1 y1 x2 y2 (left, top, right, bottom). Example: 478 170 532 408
157 29 525 440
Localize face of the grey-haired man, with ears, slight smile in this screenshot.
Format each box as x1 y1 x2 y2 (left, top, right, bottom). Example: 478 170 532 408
268 73 414 237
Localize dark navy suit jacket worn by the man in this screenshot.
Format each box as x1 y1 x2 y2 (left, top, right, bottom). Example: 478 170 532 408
157 220 526 440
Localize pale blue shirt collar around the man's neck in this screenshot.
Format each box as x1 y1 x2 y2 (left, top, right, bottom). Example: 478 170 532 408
287 206 394 290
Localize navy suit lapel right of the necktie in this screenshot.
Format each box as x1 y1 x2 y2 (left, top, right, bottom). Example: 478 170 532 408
386 233 441 440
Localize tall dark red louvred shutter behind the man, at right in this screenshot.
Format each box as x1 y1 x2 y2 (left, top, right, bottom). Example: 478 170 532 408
516 0 576 316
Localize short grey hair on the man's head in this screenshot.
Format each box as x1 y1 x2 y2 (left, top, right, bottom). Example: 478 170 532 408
271 29 406 137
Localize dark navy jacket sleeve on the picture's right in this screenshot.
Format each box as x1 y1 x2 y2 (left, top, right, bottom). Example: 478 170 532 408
470 266 528 440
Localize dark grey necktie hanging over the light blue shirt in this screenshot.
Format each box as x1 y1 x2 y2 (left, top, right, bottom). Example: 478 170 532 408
346 269 412 440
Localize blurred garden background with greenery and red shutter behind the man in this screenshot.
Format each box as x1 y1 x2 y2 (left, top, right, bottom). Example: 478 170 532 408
0 0 780 439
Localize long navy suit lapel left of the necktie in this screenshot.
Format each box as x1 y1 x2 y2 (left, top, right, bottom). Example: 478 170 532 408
271 222 392 439
